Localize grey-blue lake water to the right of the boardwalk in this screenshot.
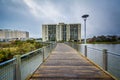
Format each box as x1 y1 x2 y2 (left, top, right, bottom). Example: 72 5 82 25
67 44 120 80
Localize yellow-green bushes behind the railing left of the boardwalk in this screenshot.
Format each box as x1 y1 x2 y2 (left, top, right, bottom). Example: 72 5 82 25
0 40 43 62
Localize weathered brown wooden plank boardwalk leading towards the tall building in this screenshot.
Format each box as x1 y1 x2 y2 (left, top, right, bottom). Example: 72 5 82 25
30 43 114 80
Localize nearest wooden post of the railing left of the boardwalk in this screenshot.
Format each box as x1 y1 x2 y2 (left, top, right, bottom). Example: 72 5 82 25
14 55 21 80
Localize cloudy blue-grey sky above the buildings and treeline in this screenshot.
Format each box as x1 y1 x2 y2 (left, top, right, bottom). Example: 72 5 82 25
0 0 120 38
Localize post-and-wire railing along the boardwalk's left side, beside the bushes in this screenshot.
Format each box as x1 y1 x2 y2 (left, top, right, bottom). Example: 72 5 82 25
0 43 56 80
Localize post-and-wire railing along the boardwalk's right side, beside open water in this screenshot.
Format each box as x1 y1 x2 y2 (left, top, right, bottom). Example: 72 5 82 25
66 43 120 80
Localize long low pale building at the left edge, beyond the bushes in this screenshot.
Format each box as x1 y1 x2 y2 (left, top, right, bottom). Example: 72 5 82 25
0 29 29 41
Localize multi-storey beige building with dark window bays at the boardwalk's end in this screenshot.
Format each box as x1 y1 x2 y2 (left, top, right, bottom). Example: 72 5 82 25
42 23 81 42
